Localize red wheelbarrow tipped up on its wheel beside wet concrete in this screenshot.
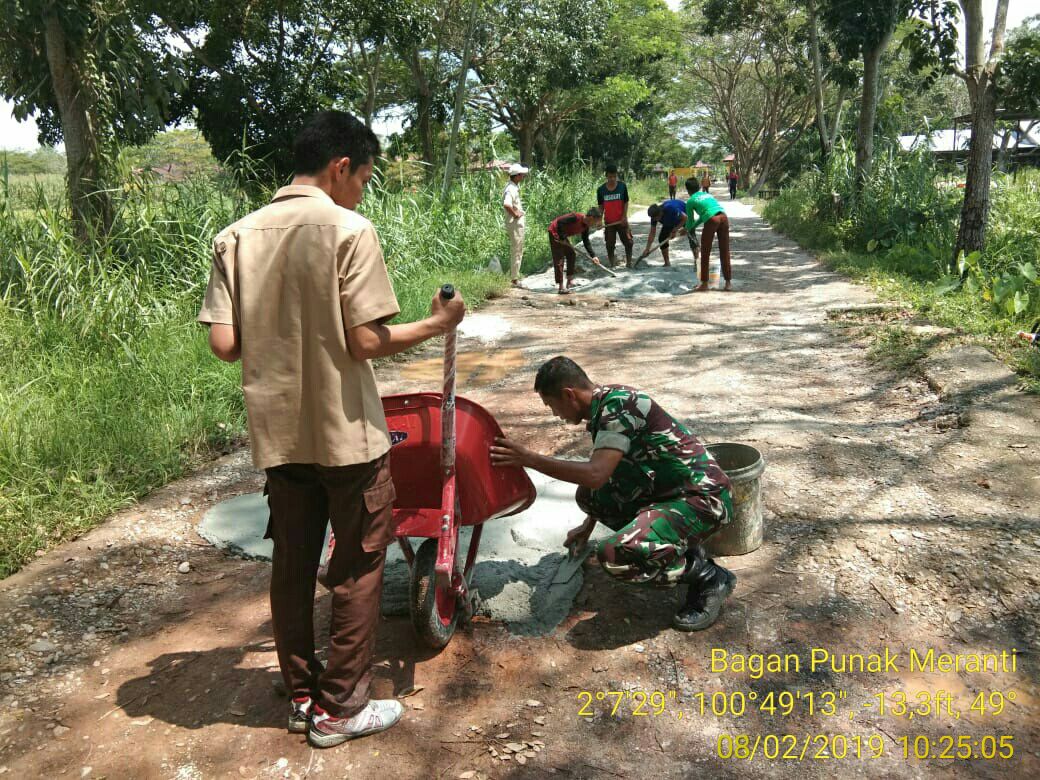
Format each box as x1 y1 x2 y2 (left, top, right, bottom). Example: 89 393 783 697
327 285 535 649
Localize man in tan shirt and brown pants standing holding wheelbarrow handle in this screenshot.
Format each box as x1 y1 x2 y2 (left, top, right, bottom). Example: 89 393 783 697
199 111 465 748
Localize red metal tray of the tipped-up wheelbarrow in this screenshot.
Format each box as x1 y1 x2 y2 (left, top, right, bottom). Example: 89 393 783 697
383 393 536 538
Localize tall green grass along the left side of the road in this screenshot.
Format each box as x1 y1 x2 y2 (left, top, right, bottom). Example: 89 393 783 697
0 165 593 576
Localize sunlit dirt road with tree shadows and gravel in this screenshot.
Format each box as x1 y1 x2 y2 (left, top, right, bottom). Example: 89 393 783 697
0 192 1040 780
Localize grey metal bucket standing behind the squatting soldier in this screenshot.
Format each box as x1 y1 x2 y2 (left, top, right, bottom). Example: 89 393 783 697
704 442 765 555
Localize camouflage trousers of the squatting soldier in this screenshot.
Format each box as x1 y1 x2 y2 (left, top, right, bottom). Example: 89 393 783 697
575 488 733 588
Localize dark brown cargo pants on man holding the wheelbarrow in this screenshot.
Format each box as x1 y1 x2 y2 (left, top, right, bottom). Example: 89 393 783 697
266 453 395 718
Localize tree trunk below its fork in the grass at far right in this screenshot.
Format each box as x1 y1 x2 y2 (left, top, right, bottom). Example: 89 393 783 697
954 76 996 266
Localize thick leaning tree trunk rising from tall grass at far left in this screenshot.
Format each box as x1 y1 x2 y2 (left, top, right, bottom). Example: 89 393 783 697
44 12 112 240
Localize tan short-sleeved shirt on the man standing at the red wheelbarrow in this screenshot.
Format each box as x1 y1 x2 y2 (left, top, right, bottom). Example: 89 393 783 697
199 185 400 468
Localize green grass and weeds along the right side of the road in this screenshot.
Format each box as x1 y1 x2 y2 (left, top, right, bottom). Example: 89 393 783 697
763 146 1040 388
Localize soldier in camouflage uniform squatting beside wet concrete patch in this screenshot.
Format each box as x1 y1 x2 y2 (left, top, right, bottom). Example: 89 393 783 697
491 356 736 631
